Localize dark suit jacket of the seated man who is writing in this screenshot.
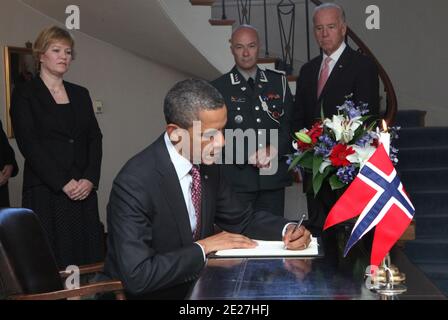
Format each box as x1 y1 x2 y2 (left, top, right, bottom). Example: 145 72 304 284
105 135 287 299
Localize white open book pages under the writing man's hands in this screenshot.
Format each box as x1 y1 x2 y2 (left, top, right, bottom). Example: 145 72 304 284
215 237 319 257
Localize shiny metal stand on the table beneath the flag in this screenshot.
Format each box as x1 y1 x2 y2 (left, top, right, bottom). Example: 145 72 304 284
371 254 407 297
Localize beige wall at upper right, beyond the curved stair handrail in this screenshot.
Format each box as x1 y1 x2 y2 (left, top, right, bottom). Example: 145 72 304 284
336 0 448 126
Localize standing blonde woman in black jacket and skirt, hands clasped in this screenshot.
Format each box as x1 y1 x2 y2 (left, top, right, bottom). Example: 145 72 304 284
11 26 104 268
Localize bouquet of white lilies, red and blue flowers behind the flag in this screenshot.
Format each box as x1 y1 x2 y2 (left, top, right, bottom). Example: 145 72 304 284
288 96 398 195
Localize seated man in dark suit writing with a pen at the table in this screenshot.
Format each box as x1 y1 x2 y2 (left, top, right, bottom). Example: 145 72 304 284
105 80 310 299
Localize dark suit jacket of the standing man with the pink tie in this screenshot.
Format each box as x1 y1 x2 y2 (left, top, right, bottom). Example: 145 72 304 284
293 46 379 131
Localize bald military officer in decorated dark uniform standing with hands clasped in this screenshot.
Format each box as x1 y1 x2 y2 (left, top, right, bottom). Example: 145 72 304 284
212 25 293 216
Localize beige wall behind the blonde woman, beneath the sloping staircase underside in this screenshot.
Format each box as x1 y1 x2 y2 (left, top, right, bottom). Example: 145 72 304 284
0 0 186 222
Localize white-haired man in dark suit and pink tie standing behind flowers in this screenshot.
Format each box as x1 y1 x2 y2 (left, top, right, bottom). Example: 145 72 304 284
293 3 379 229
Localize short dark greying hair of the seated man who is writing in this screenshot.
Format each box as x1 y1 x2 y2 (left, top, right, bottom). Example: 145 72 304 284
163 79 224 129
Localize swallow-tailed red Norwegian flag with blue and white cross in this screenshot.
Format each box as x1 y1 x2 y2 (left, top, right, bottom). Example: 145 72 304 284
324 144 415 266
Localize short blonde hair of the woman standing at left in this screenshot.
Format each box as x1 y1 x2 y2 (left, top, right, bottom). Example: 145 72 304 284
33 26 75 62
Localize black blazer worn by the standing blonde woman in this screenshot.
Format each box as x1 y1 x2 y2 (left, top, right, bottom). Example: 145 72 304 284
11 77 102 192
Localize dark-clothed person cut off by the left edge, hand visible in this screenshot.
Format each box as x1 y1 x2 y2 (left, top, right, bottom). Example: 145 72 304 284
0 121 19 208
